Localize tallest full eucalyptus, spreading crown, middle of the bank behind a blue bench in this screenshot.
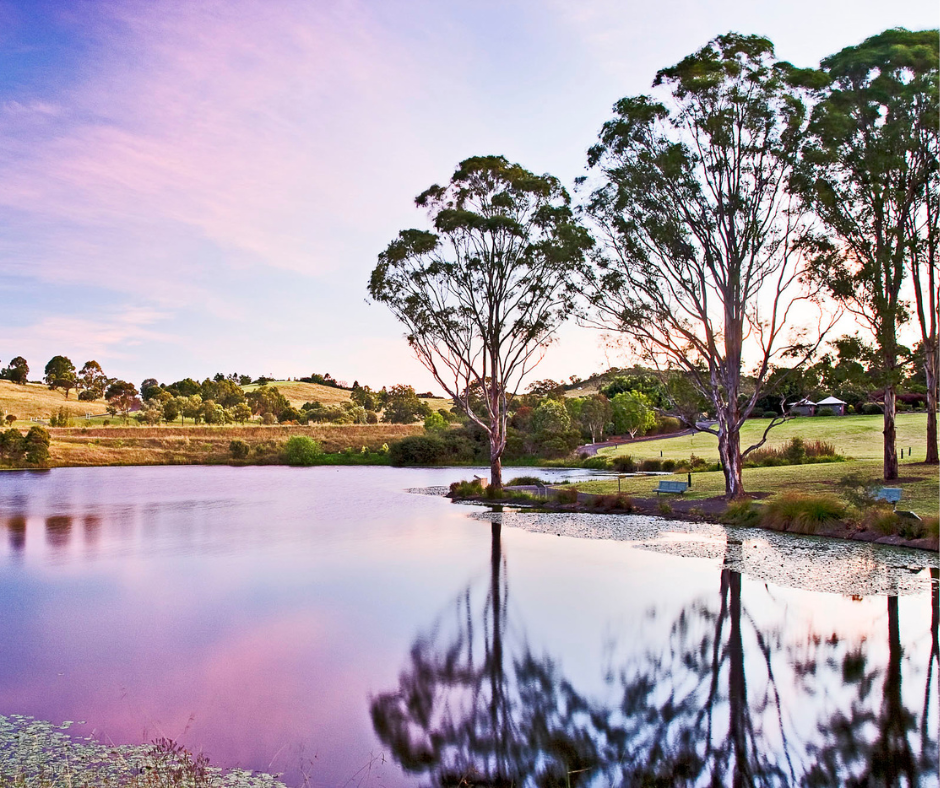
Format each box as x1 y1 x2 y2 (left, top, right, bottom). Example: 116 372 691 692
584 33 834 498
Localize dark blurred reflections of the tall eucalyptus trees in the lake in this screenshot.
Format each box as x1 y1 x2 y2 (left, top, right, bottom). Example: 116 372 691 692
371 522 940 786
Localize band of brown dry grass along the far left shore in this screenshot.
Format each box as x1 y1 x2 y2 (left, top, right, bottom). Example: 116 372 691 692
49 424 423 467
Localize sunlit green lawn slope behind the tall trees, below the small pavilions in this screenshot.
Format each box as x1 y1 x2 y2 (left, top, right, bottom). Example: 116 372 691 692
598 413 927 462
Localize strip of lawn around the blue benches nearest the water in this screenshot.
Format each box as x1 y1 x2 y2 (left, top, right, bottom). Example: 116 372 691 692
578 458 940 517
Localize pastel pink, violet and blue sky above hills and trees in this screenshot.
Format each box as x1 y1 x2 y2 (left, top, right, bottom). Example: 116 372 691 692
0 0 940 391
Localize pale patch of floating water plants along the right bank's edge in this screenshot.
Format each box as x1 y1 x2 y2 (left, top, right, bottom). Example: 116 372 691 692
471 511 937 596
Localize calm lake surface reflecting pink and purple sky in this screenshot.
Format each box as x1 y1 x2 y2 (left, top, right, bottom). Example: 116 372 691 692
0 467 940 786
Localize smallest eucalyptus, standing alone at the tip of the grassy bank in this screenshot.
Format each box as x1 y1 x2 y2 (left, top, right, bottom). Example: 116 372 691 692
369 156 591 487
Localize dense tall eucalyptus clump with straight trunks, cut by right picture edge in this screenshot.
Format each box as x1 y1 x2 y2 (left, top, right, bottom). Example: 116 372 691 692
794 29 938 480
